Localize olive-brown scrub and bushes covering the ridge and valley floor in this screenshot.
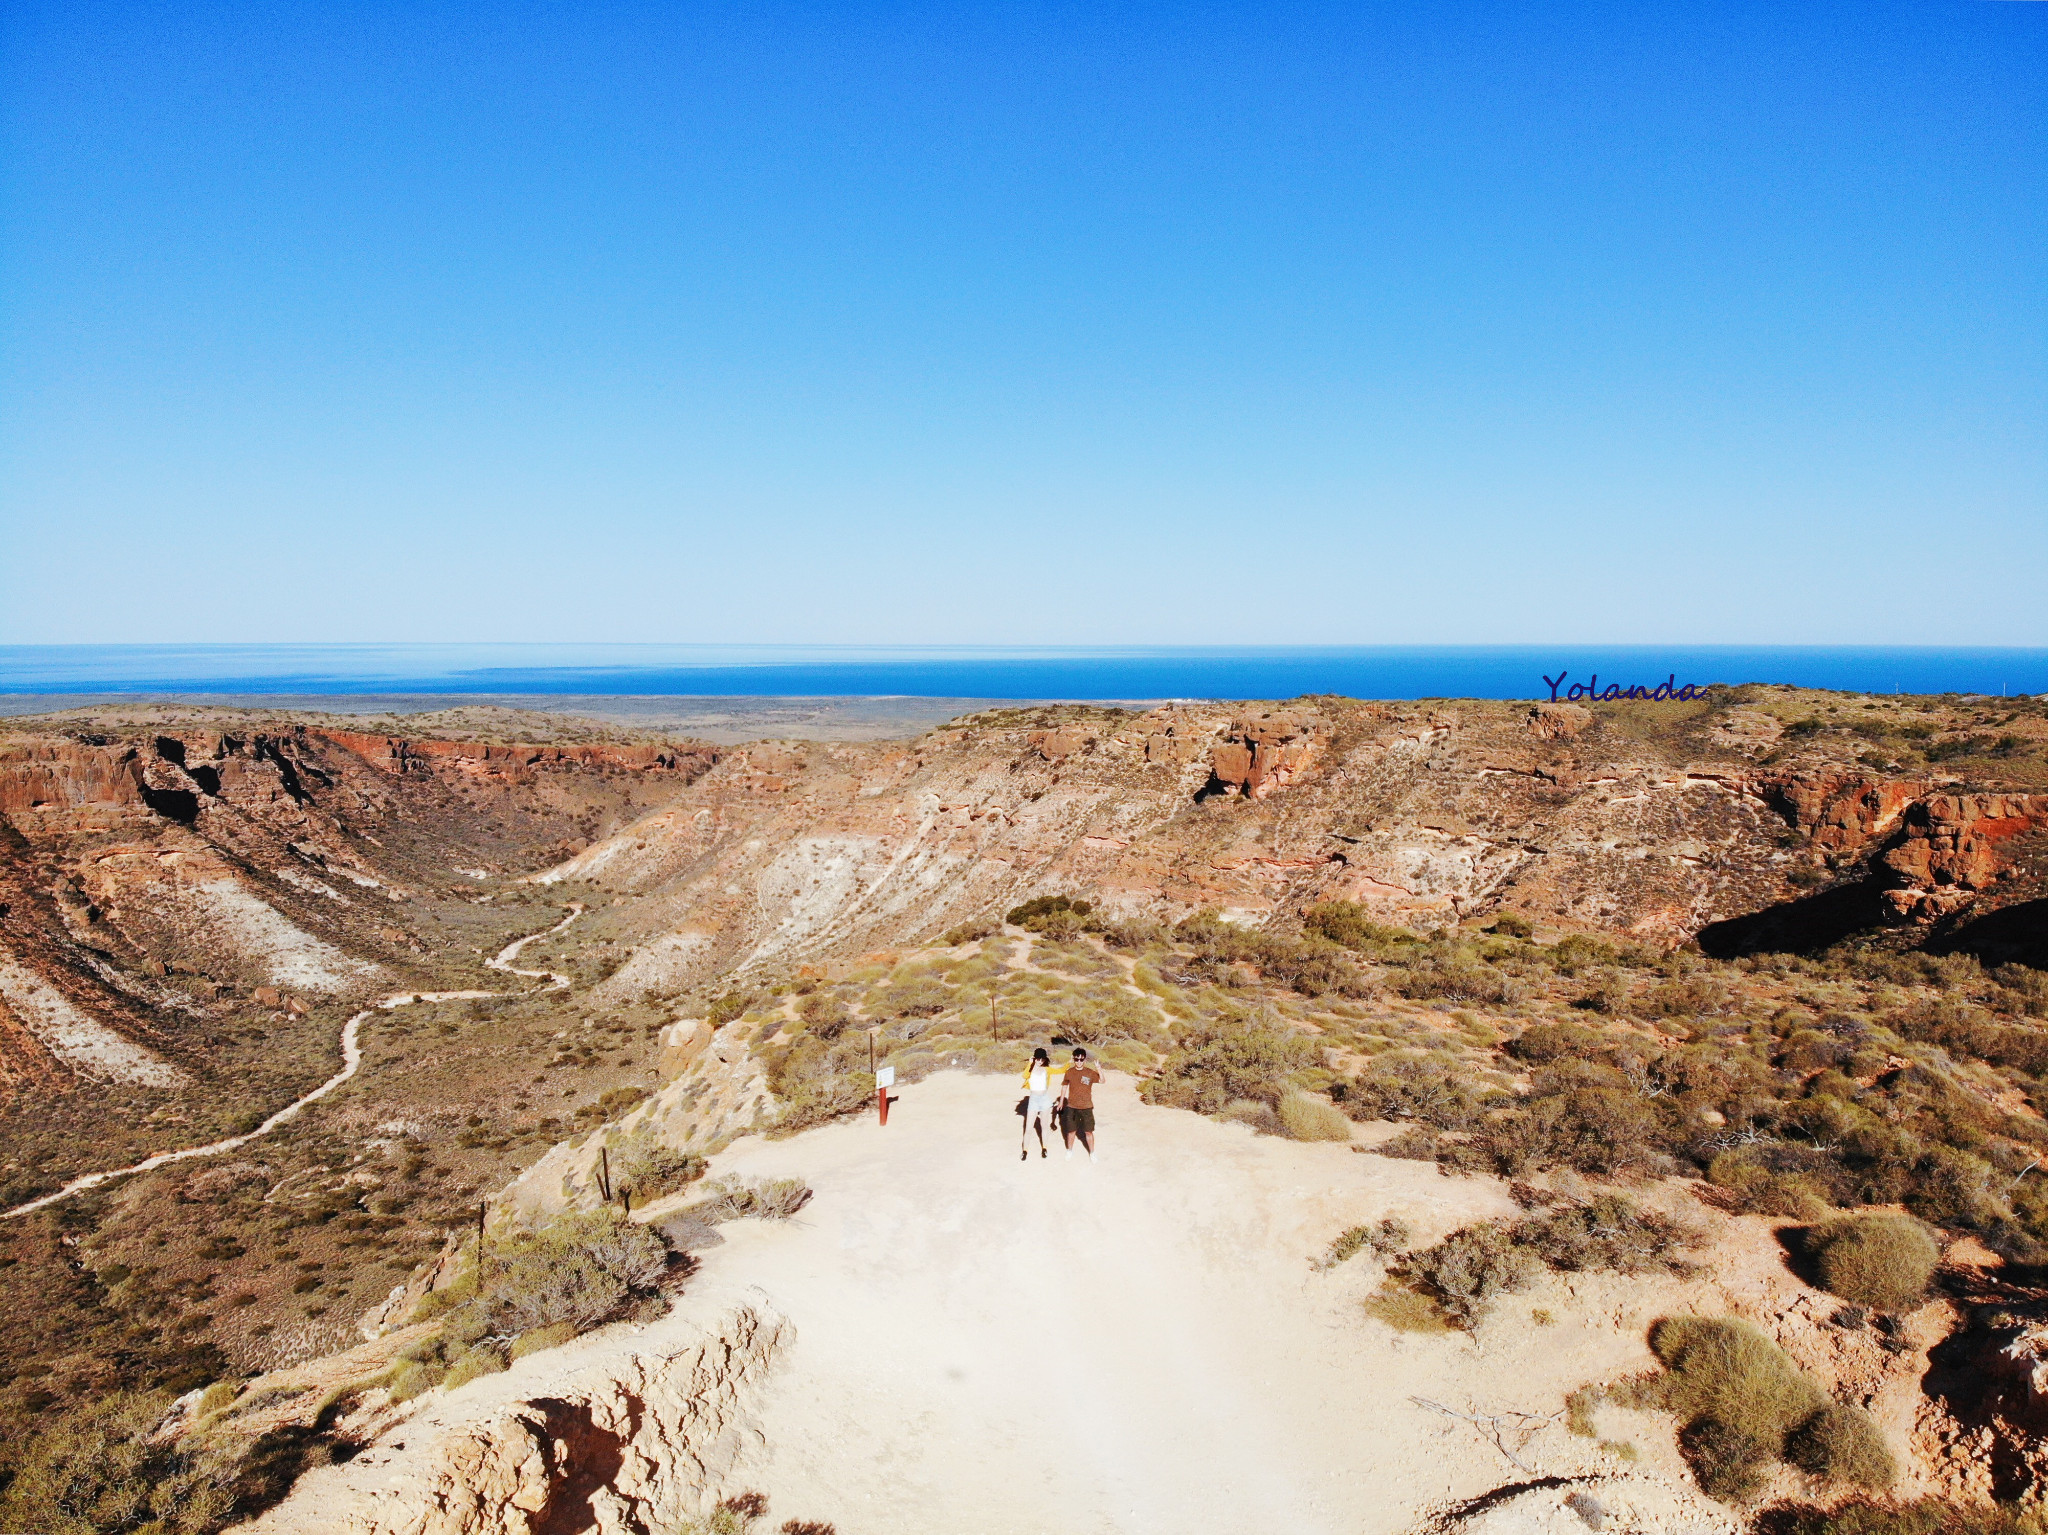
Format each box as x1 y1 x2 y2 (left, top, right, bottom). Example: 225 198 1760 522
0 798 2048 1535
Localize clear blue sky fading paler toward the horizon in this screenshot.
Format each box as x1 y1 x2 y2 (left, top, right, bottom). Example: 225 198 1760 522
0 0 2048 645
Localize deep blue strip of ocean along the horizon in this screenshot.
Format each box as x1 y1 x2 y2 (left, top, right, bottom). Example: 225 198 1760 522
0 645 2048 700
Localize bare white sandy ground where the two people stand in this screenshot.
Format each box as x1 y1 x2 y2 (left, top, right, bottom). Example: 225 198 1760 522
243 1072 1733 1535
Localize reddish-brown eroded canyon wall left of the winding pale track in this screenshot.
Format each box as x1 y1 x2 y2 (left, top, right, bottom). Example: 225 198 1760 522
0 729 719 1093
